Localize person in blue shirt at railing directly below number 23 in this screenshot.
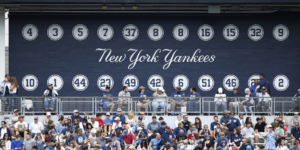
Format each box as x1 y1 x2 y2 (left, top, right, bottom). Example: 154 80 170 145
98 86 115 112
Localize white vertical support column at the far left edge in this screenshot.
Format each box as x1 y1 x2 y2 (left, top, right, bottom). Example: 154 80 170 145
0 7 5 80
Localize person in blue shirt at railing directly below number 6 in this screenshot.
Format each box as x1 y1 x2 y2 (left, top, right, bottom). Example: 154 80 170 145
168 86 187 116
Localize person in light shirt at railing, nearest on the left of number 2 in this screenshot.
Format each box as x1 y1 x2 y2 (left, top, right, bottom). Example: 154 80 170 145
255 86 272 112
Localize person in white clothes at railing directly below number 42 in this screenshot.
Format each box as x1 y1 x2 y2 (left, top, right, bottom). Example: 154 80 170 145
152 87 168 113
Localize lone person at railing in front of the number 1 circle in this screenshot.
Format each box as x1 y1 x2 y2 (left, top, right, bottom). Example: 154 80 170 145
43 83 59 111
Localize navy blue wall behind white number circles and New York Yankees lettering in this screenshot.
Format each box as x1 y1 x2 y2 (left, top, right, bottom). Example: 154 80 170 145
9 14 300 96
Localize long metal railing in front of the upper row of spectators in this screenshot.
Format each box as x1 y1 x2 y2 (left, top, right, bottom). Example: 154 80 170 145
0 96 300 115
